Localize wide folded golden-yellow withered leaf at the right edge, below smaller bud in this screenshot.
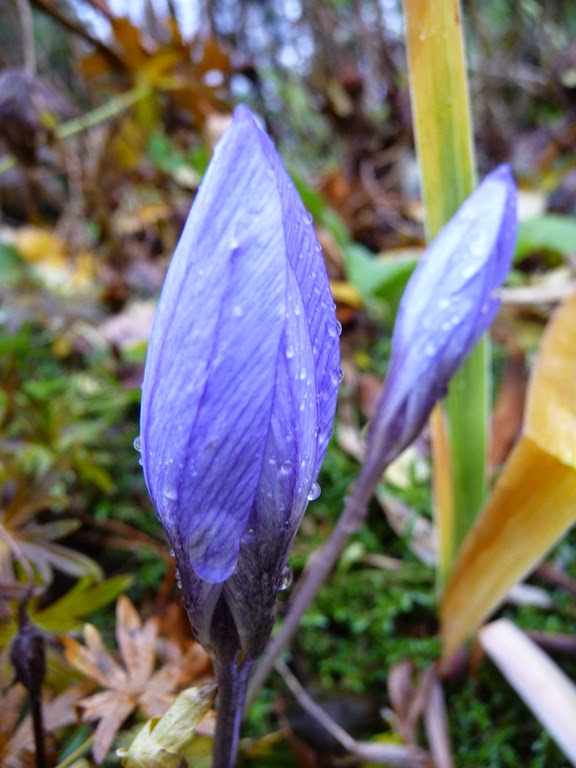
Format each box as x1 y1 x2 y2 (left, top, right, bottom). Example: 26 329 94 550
440 295 576 658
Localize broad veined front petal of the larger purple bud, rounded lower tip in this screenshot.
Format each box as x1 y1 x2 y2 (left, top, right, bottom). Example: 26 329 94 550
141 111 286 581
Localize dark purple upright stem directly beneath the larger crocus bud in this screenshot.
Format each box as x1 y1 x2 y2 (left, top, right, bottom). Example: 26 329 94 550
212 660 253 768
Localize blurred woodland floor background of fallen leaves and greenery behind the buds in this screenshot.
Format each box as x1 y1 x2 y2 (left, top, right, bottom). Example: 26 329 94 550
0 0 576 768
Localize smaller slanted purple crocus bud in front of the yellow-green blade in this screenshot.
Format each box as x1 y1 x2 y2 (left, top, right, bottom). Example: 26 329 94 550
364 165 517 474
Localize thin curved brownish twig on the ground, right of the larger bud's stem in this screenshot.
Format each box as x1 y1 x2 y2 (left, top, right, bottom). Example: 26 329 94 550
274 659 429 768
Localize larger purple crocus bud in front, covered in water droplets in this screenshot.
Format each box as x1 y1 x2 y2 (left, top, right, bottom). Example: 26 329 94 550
141 107 339 659
